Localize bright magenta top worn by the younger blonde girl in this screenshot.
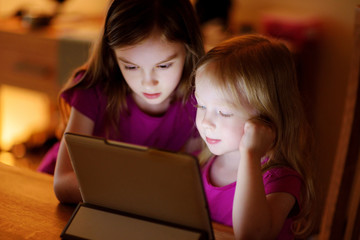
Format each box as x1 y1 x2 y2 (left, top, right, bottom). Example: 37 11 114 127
202 156 302 239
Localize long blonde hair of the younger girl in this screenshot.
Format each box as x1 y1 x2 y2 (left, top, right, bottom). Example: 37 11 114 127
195 35 315 237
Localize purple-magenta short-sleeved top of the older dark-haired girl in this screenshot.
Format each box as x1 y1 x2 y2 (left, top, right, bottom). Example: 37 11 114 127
61 86 197 151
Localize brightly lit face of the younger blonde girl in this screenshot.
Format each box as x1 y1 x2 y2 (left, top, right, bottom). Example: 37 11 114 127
195 70 255 155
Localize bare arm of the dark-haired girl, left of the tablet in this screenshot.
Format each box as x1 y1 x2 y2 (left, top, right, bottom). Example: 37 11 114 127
54 107 94 203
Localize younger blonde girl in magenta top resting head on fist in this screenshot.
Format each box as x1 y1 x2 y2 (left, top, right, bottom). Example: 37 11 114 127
195 35 314 239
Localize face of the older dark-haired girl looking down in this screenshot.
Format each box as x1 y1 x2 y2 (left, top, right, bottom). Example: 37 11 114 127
115 35 186 113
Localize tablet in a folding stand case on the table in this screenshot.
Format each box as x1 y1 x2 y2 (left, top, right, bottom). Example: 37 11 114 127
62 133 214 239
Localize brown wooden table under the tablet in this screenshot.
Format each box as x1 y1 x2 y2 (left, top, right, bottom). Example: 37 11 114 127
0 163 234 240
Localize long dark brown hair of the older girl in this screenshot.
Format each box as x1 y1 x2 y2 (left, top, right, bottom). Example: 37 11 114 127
60 0 204 133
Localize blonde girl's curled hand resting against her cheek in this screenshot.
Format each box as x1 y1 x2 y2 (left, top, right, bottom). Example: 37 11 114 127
239 120 275 159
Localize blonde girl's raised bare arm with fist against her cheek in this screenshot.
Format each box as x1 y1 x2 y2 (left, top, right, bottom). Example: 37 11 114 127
233 121 295 239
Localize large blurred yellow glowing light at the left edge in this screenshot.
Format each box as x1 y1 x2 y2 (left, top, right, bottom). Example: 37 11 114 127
0 85 50 151
